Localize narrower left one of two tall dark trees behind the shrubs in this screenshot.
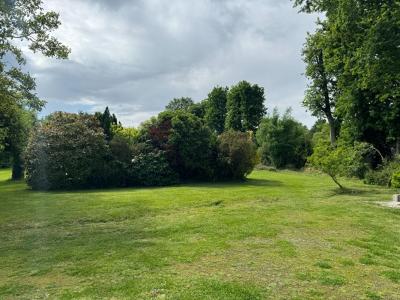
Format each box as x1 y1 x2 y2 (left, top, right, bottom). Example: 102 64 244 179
204 87 228 134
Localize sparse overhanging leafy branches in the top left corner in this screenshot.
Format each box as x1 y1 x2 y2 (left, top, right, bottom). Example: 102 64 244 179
0 0 69 110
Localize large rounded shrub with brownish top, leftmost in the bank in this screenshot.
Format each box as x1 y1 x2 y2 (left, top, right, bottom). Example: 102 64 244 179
26 112 110 190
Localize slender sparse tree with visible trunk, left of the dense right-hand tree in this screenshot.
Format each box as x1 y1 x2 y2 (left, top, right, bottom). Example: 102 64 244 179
303 30 338 145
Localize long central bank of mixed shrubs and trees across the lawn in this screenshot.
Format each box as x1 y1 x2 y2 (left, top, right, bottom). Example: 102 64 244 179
26 81 318 190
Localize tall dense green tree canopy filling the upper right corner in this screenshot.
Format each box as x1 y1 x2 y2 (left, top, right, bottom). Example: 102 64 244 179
295 0 400 155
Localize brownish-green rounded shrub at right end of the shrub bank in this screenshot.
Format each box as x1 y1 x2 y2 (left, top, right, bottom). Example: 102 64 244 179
218 131 257 179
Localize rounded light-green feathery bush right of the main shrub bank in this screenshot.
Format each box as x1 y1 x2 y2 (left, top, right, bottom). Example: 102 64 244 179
256 110 311 169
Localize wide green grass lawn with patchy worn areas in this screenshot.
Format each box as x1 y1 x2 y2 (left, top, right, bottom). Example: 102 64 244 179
0 171 400 299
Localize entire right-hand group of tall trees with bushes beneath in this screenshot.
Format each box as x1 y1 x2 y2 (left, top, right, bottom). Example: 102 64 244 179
294 0 400 185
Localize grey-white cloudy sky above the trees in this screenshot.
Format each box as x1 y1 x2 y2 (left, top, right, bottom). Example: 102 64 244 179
28 0 316 126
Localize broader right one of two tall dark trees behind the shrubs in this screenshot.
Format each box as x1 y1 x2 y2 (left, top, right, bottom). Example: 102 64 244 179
225 81 266 132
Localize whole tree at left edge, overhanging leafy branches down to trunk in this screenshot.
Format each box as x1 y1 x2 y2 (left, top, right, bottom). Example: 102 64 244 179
0 0 69 179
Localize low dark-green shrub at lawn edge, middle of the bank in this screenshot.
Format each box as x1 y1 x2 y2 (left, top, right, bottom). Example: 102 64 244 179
129 151 178 186
